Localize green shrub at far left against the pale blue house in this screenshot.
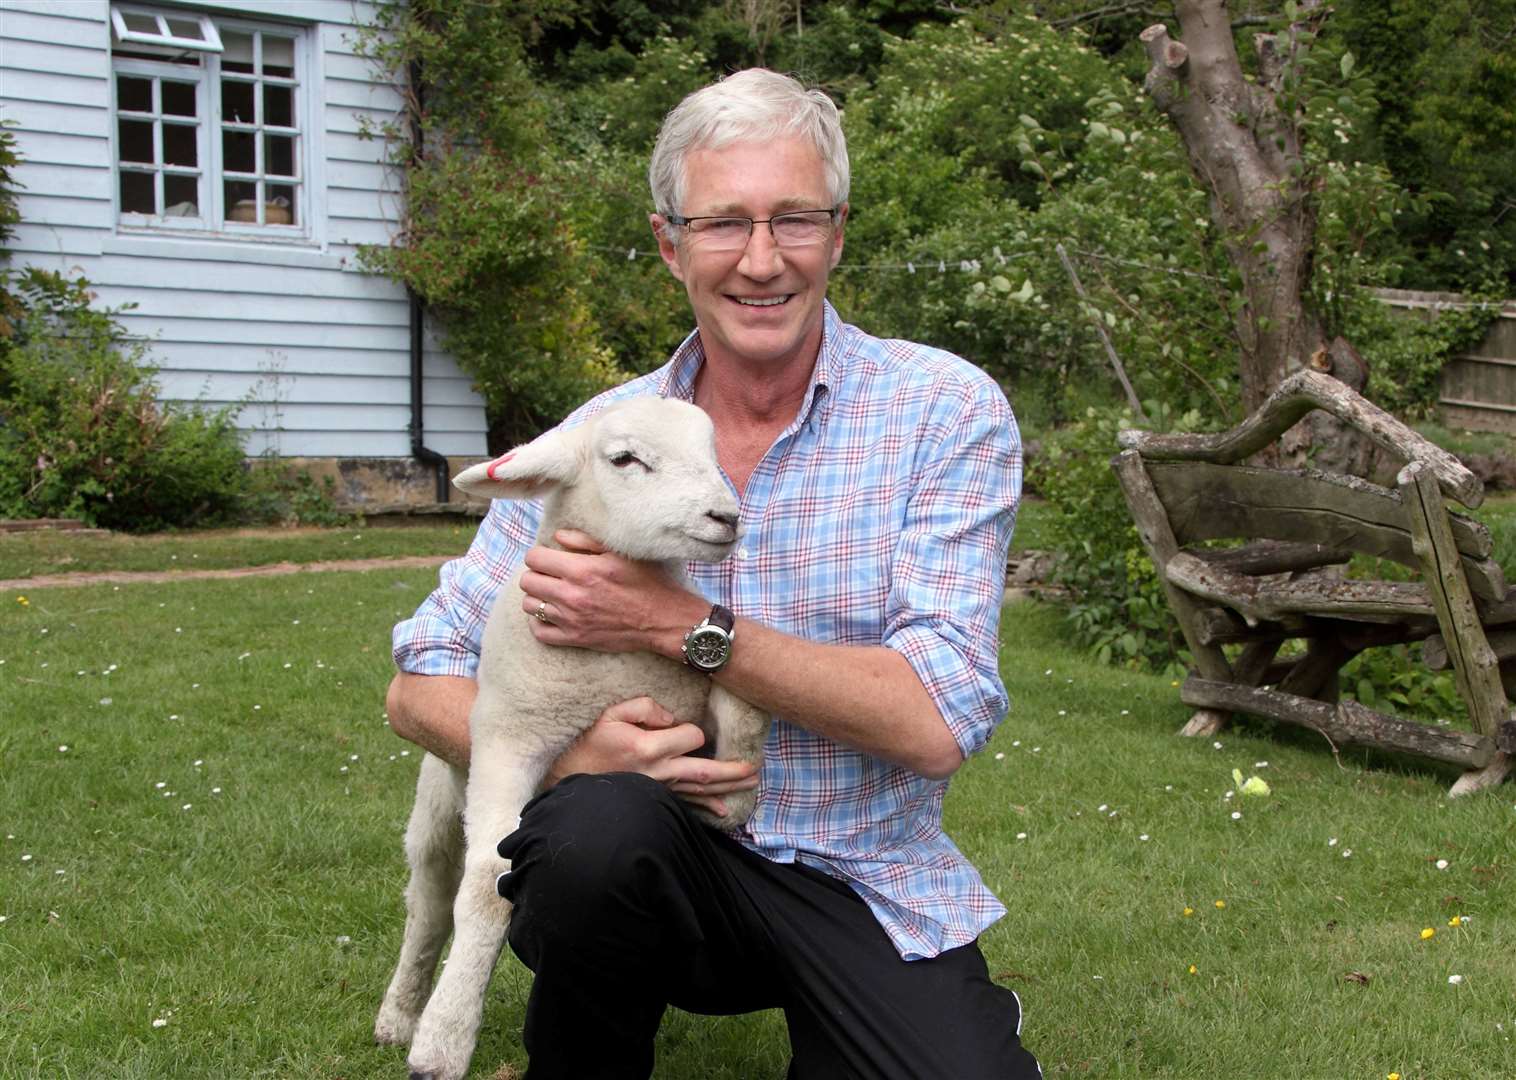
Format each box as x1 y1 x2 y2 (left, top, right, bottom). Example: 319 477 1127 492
0 280 246 529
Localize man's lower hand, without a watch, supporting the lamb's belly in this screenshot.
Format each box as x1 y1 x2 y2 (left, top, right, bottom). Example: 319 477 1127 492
544 698 758 818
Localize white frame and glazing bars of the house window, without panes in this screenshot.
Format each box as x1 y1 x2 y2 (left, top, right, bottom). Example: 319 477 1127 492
111 5 318 244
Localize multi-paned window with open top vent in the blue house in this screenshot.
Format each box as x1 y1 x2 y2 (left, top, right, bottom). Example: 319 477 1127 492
111 5 311 238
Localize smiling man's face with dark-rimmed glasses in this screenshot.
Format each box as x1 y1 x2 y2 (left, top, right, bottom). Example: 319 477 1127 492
653 138 846 367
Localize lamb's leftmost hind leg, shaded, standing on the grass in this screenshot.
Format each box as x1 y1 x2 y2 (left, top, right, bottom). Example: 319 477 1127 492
374 754 465 1047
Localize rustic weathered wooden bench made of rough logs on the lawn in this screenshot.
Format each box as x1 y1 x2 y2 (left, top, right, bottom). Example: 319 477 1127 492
1111 370 1516 795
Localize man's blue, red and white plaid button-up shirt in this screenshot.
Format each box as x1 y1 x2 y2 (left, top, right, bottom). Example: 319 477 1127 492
394 303 1022 960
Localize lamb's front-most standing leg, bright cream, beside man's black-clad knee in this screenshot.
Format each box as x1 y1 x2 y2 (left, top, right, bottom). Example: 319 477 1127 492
408 746 561 1080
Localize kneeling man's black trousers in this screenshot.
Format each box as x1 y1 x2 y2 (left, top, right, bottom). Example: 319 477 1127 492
500 774 1041 1080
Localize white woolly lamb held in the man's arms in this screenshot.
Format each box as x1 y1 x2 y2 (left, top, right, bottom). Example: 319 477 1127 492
374 397 769 1080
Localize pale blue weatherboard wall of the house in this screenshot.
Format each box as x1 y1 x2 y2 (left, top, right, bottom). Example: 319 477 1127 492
0 0 485 457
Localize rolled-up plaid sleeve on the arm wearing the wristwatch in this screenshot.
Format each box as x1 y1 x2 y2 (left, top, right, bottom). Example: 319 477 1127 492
884 378 1022 757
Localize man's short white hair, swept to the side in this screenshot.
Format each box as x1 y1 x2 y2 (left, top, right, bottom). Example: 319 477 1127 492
647 68 849 222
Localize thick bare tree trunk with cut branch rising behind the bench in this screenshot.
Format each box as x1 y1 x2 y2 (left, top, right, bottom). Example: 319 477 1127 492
1142 0 1328 413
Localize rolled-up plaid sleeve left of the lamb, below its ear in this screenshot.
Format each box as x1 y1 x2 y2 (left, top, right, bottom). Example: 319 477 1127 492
393 499 541 678
